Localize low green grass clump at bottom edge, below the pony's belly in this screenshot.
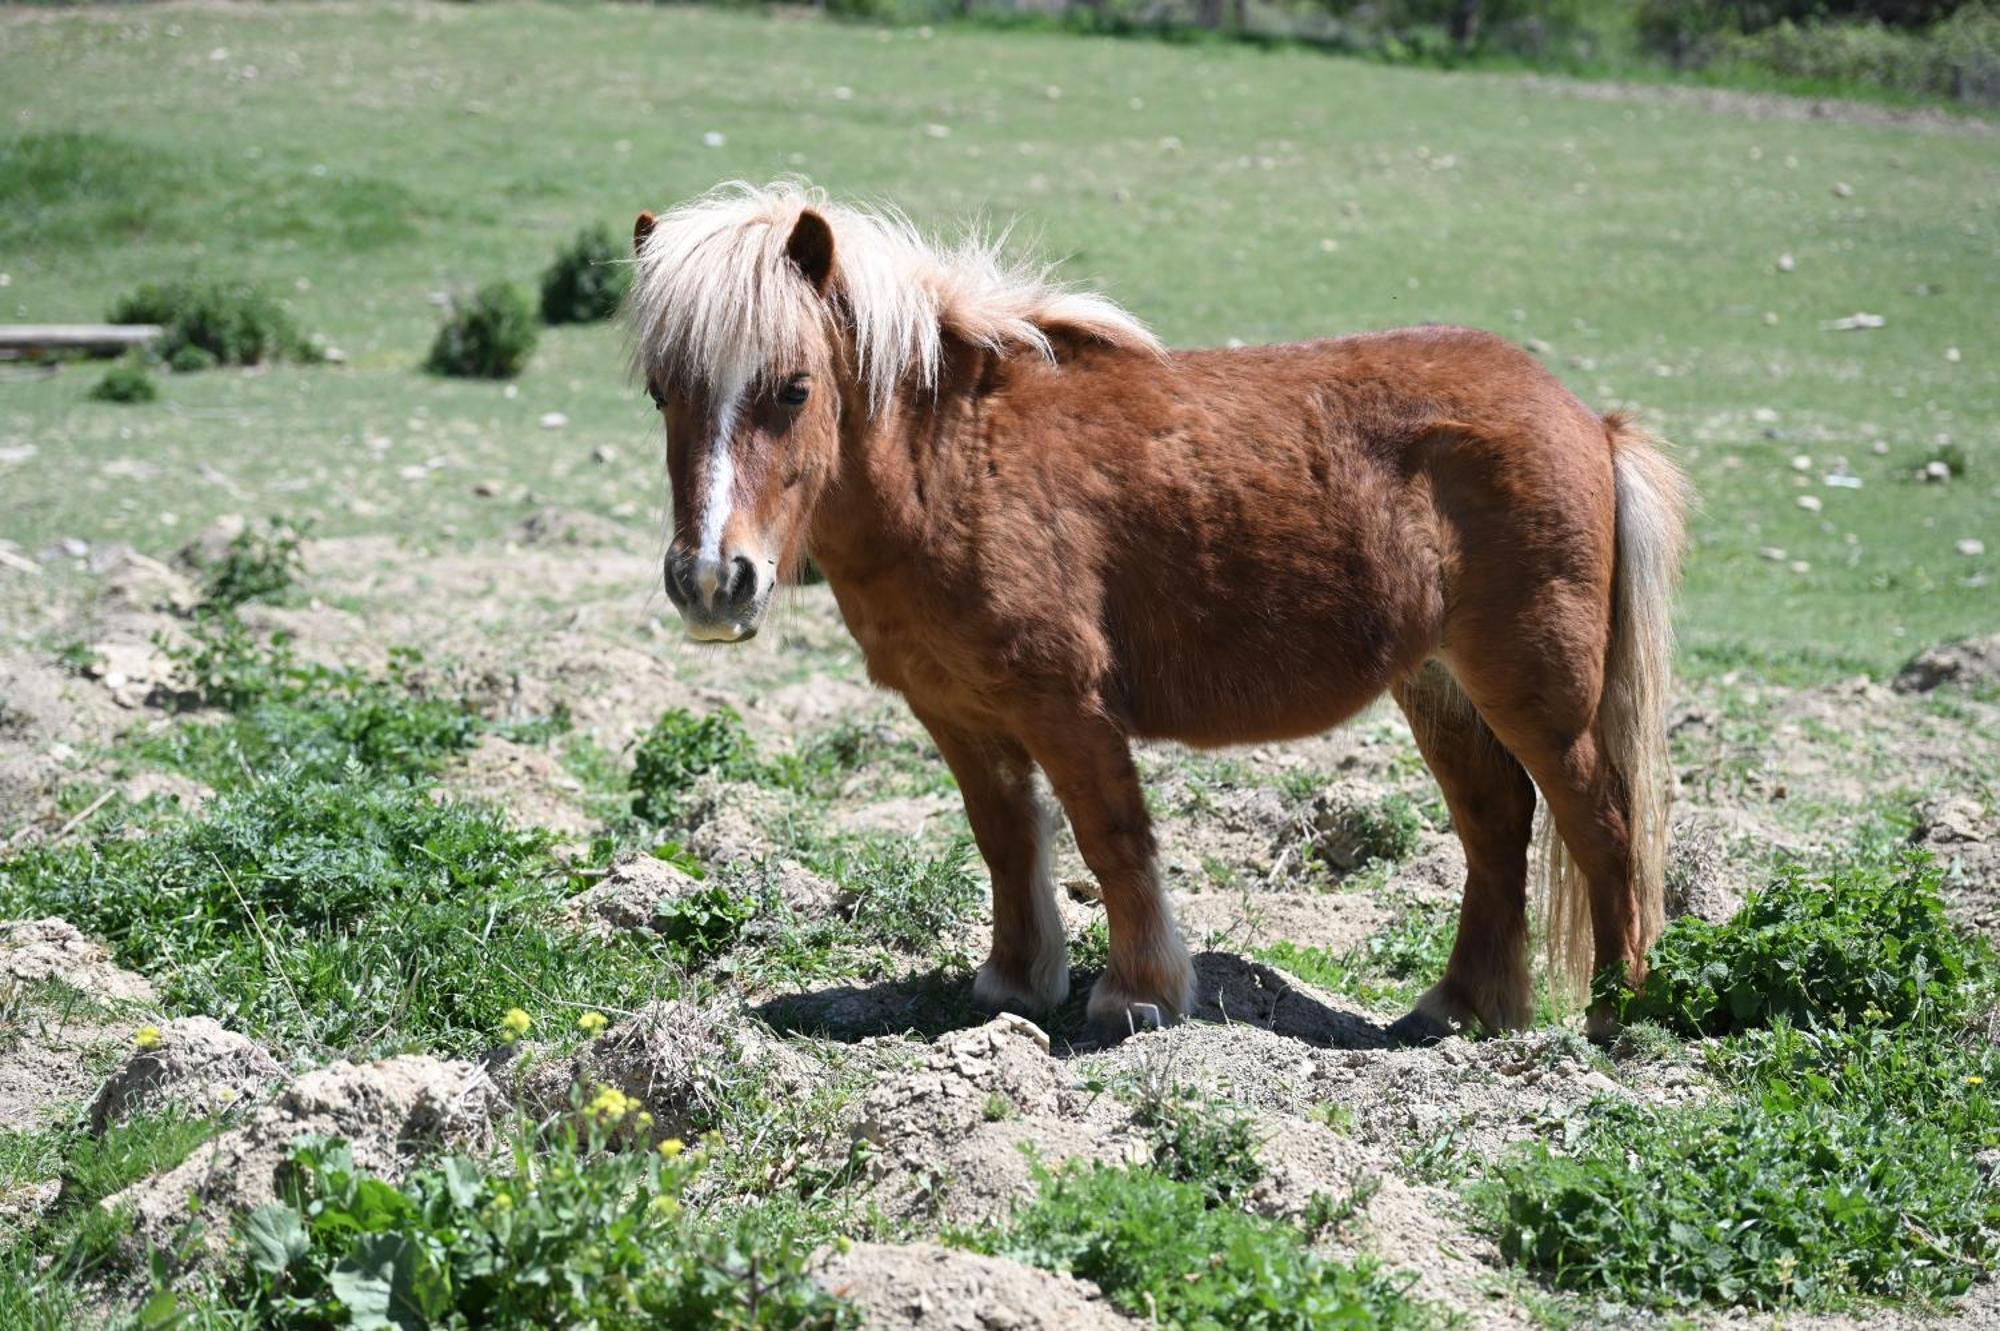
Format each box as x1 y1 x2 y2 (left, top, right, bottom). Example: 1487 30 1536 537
962 1165 1440 1331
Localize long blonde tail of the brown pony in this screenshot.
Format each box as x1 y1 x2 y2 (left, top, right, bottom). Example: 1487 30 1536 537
1536 414 1690 995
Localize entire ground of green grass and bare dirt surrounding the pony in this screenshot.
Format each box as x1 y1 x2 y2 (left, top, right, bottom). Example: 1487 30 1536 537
0 0 2000 1331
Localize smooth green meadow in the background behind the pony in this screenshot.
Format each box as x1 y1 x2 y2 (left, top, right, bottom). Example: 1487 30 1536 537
0 4 2000 675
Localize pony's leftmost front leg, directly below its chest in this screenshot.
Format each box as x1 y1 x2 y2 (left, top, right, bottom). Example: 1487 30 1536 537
918 713 1070 1013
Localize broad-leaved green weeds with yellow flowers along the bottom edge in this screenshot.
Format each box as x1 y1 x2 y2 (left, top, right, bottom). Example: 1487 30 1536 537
172 1129 856 1331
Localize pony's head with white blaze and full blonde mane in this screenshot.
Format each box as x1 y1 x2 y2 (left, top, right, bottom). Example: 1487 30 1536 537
630 182 1158 642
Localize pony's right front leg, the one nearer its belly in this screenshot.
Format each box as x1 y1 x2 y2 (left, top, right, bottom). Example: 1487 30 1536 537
1026 717 1196 1031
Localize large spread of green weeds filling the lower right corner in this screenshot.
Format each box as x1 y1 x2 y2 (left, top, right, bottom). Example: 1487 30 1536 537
1474 851 2000 1309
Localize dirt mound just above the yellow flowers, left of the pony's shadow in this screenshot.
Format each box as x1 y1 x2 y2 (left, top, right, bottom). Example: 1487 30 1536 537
514 999 820 1137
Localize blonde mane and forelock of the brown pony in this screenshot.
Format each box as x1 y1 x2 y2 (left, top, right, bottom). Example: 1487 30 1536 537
630 182 1160 412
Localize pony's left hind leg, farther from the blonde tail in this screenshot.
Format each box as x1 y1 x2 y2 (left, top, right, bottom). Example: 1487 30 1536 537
1390 662 1534 1043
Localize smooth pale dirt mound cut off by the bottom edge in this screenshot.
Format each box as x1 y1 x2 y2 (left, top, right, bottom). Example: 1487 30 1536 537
818 1243 1140 1331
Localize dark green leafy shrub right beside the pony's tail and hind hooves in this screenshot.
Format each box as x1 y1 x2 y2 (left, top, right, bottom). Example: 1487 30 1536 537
1598 859 1990 1035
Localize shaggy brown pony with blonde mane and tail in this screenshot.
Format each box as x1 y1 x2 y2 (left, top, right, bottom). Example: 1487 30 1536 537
632 184 1684 1039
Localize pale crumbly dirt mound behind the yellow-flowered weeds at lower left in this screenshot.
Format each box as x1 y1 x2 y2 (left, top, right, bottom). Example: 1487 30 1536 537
104 1053 506 1245
